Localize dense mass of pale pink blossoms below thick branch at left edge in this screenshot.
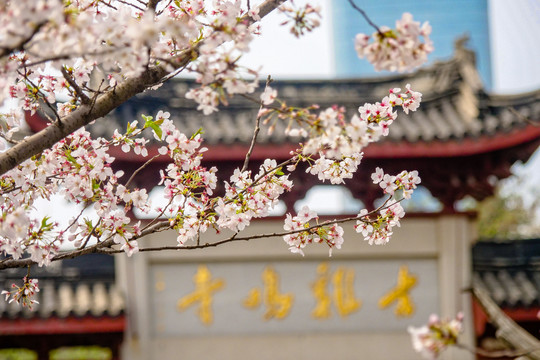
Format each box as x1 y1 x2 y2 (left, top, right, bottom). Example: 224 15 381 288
0 124 149 266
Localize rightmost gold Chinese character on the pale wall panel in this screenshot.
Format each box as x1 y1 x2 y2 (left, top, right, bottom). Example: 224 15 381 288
379 266 417 317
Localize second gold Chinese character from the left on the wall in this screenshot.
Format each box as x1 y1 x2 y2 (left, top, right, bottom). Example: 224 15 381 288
244 266 294 320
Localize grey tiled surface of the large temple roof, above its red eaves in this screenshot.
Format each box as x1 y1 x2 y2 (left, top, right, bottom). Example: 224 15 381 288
56 44 540 156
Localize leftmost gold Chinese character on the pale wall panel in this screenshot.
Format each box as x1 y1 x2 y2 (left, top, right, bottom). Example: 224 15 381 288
176 265 225 325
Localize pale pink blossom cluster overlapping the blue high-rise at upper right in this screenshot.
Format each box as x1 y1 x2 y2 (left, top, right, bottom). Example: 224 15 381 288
354 13 433 72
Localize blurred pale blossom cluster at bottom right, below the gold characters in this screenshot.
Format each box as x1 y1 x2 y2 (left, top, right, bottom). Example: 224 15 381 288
408 313 463 359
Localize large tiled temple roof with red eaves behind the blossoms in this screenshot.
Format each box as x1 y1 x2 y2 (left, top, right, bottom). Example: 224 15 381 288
28 41 540 210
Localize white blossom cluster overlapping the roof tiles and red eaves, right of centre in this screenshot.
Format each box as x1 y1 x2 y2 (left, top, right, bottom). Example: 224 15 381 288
274 84 422 184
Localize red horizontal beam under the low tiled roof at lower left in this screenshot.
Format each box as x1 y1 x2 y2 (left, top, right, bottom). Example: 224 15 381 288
0 315 126 336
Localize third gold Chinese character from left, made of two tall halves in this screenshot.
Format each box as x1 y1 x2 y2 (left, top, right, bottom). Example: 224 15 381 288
311 263 362 319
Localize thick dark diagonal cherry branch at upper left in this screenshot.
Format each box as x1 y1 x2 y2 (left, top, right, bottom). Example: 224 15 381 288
0 0 284 175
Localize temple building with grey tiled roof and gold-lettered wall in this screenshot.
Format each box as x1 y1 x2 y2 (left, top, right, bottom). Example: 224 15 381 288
9 42 540 359
